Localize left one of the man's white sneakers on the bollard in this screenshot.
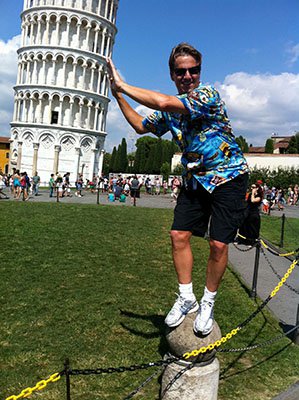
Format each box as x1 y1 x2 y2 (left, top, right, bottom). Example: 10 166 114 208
165 295 199 328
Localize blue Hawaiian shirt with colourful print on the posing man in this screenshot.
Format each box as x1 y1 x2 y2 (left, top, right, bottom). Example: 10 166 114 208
142 84 248 192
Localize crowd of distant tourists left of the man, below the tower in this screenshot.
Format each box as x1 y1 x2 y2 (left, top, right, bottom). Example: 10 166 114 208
0 168 185 202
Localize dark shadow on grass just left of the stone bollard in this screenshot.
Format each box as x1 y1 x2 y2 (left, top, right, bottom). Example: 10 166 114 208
120 310 168 357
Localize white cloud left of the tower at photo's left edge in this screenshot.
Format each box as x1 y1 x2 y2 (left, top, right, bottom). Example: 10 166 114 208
0 35 21 136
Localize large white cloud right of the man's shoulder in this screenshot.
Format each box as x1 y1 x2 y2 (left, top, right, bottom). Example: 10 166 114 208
217 72 299 146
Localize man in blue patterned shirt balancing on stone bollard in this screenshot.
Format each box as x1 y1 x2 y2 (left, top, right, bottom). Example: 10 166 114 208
107 43 248 335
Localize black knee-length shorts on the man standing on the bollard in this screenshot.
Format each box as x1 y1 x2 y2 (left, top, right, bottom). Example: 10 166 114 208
171 174 248 244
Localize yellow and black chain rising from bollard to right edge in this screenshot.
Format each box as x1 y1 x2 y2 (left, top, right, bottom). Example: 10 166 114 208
183 260 298 360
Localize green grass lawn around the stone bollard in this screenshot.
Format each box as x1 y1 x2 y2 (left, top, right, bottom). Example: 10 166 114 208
0 202 299 400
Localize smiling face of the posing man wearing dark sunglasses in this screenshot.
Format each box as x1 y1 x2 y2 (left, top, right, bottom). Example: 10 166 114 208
171 56 200 94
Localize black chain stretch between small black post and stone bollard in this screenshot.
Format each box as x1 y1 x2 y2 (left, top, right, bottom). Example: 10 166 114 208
68 357 179 375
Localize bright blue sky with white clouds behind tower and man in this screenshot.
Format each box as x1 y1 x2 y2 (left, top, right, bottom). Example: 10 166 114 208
0 0 299 151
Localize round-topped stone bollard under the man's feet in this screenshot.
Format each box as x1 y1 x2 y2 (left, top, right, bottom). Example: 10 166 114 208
160 313 221 400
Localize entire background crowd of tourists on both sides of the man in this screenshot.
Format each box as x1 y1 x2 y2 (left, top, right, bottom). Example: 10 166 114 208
0 168 299 209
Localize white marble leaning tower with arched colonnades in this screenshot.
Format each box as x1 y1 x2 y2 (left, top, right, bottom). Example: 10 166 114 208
10 0 118 182
